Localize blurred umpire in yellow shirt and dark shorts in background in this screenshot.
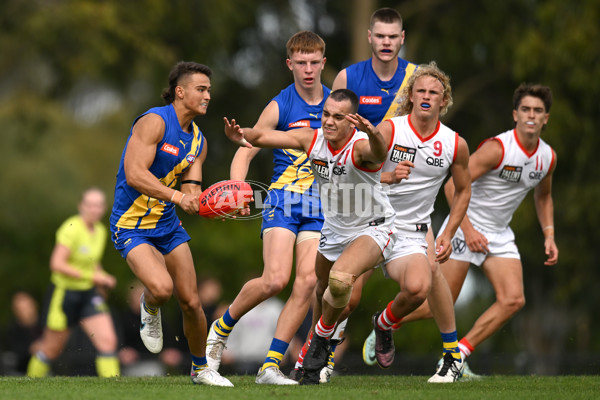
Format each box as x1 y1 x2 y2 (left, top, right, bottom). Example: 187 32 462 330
27 188 120 378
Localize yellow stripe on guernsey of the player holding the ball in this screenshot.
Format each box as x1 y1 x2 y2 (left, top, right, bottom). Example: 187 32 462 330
117 124 201 229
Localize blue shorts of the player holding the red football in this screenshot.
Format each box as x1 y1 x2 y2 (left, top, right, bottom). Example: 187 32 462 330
112 224 191 258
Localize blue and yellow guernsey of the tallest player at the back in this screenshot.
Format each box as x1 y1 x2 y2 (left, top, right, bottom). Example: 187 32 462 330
346 57 417 126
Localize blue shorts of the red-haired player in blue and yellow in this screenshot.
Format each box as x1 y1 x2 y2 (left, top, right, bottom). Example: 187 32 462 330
260 189 324 237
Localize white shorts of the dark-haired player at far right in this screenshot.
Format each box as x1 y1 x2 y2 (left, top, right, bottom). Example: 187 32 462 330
440 217 521 267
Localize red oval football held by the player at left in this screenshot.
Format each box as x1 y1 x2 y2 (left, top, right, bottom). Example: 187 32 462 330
198 180 253 218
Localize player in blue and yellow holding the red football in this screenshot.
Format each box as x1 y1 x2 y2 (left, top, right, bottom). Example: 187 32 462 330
110 61 233 386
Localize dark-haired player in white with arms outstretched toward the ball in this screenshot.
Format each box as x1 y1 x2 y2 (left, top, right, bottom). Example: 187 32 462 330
225 89 396 384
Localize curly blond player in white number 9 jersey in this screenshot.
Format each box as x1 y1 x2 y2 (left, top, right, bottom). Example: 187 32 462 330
366 62 471 383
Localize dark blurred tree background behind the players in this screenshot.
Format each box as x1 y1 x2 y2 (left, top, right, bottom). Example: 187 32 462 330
0 0 600 374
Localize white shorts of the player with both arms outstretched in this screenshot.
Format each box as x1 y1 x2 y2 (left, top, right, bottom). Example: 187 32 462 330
319 222 396 262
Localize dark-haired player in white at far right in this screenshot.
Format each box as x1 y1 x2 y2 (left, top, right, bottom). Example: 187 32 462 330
394 84 558 377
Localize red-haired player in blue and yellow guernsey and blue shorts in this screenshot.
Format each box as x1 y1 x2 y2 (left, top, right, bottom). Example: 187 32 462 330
207 31 330 385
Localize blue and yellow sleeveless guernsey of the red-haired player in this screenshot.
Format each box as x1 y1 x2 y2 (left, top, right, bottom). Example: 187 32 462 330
269 84 330 196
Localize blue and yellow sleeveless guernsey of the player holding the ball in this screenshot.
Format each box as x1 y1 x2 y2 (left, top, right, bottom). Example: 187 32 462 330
110 104 204 236
